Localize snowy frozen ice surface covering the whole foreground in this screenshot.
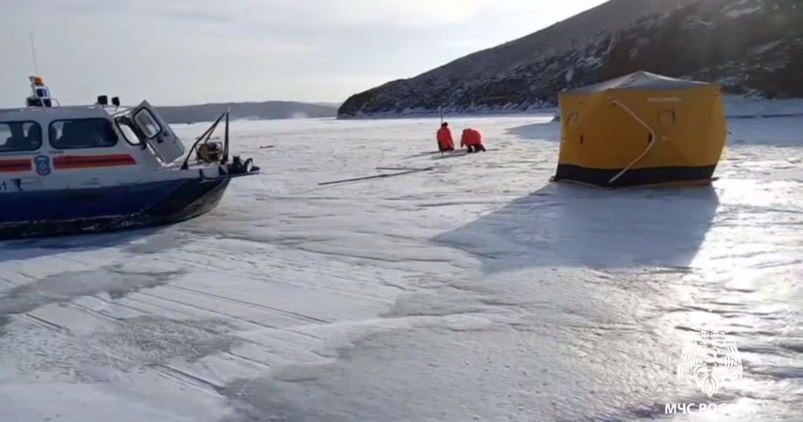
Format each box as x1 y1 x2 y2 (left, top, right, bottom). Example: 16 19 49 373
0 114 803 422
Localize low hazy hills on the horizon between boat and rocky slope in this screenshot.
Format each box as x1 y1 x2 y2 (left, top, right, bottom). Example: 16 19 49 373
156 101 337 124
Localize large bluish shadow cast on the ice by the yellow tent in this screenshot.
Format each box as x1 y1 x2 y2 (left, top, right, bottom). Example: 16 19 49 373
432 183 719 273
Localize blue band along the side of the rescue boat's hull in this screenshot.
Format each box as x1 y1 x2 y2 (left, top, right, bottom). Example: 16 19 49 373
0 179 187 225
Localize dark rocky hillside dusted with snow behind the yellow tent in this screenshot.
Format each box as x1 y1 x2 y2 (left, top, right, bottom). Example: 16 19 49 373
338 0 803 118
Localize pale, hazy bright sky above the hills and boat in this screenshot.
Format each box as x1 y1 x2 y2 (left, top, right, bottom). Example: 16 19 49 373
0 0 604 107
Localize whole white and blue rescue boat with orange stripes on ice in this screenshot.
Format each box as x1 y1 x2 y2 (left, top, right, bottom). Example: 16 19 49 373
0 76 259 240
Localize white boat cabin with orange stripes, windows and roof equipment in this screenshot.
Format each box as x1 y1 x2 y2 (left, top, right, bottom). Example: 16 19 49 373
0 76 198 191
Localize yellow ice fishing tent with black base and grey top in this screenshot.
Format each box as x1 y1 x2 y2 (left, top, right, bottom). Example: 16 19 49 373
552 72 727 187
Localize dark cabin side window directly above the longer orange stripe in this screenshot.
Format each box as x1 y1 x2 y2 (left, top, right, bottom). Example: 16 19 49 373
50 118 119 149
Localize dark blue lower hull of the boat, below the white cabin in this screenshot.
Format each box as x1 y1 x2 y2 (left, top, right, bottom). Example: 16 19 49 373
0 177 231 240
